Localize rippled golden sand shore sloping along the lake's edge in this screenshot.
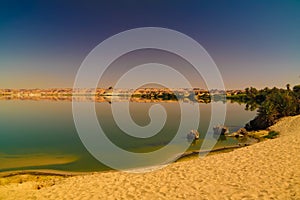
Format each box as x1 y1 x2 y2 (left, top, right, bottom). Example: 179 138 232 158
0 116 300 199
